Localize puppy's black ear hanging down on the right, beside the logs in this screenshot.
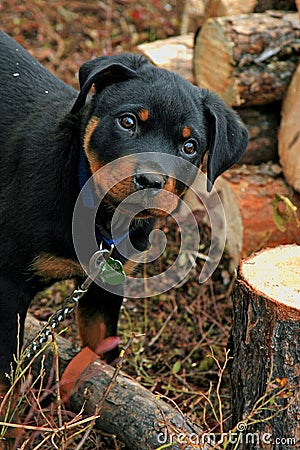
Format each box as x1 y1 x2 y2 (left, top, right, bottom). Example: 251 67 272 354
203 91 248 192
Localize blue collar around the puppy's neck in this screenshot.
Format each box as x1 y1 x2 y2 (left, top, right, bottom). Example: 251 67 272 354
78 150 130 248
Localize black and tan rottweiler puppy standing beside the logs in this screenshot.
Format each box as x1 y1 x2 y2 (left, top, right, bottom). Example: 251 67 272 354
0 32 248 402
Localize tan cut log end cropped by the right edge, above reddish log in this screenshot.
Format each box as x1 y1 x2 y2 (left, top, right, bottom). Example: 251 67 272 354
278 65 300 192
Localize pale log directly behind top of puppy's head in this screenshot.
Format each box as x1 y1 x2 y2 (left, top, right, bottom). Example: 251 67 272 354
137 33 195 83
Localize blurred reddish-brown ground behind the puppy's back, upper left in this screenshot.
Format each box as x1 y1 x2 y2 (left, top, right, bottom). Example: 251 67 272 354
0 0 181 87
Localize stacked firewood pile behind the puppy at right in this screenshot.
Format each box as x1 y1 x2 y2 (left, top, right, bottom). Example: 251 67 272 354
139 0 300 256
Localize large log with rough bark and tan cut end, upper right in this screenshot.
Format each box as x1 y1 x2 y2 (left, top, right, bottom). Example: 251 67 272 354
194 11 300 106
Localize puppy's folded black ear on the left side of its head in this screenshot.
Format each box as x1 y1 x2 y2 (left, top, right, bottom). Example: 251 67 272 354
71 56 136 114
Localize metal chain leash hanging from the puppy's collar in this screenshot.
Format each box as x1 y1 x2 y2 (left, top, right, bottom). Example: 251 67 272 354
24 246 113 358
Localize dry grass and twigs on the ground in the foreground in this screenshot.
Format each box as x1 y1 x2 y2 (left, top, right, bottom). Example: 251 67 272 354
2 219 237 450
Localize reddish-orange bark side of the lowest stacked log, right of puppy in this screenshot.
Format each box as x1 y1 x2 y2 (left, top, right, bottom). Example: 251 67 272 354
223 164 300 257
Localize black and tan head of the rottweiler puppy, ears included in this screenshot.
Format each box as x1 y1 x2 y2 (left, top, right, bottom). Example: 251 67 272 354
71 54 248 216
